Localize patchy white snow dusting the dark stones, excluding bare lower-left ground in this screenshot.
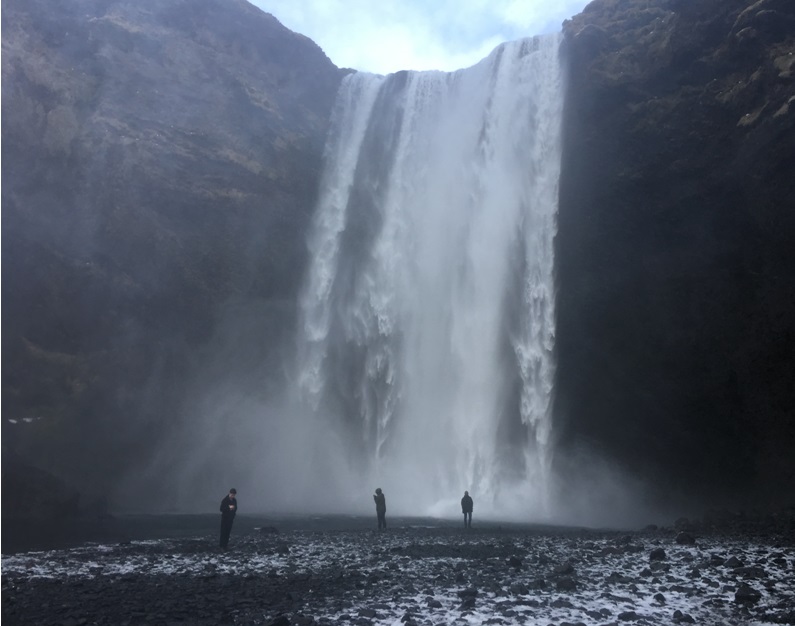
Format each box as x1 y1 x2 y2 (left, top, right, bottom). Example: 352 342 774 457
2 528 795 626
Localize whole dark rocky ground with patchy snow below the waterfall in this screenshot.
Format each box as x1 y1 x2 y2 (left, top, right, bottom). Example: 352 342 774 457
2 520 795 626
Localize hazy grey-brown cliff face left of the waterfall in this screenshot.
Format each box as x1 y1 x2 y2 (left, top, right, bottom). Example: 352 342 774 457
2 0 342 498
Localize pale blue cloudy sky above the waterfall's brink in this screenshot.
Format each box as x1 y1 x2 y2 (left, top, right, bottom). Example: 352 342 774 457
249 0 588 74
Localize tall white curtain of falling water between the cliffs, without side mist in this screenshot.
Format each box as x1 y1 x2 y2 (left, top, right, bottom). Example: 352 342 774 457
299 35 562 517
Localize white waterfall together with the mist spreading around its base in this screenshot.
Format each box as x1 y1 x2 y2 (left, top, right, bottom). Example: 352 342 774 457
109 35 672 526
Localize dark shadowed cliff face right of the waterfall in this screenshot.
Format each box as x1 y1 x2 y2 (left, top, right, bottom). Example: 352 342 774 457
557 0 795 504
